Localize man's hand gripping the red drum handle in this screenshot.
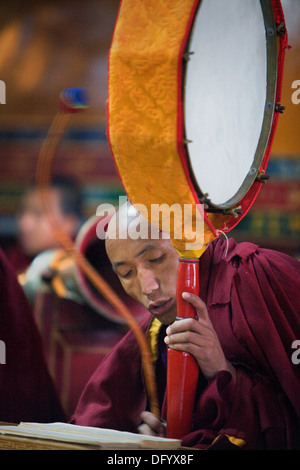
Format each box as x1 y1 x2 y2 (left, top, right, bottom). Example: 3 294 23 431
165 292 235 380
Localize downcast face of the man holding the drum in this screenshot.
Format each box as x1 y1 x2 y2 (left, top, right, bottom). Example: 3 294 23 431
106 234 179 325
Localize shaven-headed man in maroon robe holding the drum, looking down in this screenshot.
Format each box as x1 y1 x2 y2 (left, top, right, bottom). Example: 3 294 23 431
71 204 300 449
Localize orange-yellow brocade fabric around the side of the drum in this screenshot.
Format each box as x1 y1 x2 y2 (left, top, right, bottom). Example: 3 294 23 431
108 0 224 254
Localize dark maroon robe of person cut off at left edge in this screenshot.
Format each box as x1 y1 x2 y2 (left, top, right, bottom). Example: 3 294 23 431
0 251 66 423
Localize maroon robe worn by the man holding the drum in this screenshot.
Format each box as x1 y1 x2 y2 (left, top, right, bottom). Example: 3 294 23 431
71 239 300 449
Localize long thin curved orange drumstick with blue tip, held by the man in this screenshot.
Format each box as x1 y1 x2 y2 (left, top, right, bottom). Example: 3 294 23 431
36 88 160 417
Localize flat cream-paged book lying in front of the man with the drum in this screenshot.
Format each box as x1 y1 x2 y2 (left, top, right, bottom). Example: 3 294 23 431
0 423 181 450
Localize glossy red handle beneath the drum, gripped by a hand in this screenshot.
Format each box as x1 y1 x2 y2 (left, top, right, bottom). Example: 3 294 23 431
167 258 199 439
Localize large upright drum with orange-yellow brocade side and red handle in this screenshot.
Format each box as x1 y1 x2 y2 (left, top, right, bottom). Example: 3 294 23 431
108 0 287 438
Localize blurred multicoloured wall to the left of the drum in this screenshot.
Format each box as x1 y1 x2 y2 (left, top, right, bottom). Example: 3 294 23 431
0 0 122 242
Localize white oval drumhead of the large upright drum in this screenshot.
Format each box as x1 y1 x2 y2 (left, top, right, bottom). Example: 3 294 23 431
184 0 267 205
